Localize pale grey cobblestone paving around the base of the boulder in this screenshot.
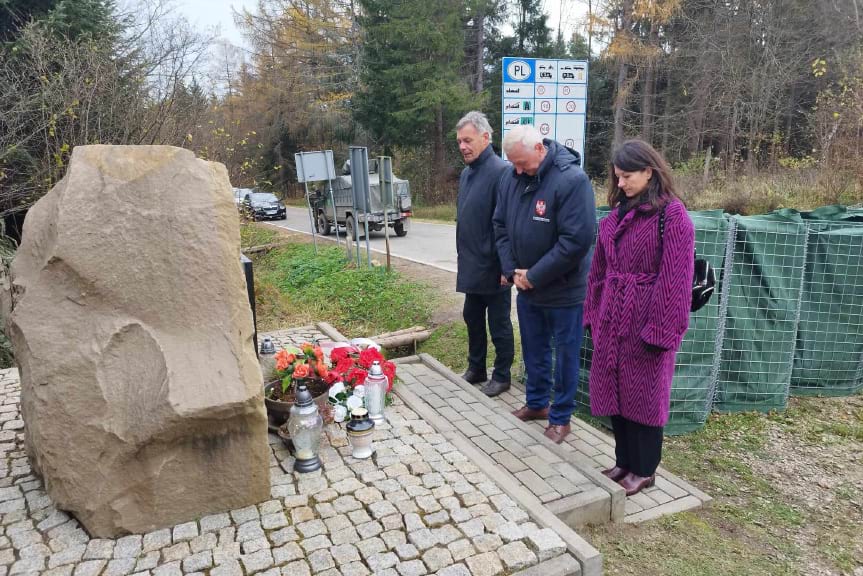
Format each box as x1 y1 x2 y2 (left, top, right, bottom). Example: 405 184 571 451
0 329 598 576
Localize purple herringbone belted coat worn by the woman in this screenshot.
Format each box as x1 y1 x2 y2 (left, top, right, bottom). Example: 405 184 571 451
584 200 695 426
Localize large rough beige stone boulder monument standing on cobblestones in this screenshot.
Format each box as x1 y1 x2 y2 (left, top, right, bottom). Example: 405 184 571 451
8 146 270 537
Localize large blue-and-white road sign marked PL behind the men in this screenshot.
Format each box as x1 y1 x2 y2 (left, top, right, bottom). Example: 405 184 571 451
501 56 587 166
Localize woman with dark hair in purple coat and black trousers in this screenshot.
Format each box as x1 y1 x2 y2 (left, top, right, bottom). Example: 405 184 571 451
584 140 695 496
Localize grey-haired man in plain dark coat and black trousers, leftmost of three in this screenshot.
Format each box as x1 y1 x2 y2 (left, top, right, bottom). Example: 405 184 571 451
455 111 514 396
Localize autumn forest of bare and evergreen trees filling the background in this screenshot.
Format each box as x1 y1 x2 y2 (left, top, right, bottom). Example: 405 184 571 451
0 0 863 234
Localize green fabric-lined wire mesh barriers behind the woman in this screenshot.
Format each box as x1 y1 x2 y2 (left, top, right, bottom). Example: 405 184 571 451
577 206 863 434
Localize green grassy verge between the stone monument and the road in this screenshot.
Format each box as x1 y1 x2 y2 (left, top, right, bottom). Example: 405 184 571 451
255 244 433 336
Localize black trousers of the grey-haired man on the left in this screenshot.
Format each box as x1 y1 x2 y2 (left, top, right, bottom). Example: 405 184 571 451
462 290 515 382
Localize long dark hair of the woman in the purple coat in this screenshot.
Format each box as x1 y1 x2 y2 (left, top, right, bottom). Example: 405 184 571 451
608 140 680 209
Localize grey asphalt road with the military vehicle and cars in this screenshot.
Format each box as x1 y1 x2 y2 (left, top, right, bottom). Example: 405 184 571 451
269 206 456 272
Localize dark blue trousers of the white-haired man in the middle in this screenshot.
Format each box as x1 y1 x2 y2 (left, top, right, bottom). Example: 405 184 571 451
516 294 584 424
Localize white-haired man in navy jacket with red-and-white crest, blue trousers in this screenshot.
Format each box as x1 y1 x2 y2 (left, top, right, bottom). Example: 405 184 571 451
494 126 596 444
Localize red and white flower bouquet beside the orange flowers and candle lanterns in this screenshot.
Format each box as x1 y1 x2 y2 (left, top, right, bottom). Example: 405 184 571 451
329 346 396 422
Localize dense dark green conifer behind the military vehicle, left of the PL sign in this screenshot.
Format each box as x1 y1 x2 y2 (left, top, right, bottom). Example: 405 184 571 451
354 0 478 200
